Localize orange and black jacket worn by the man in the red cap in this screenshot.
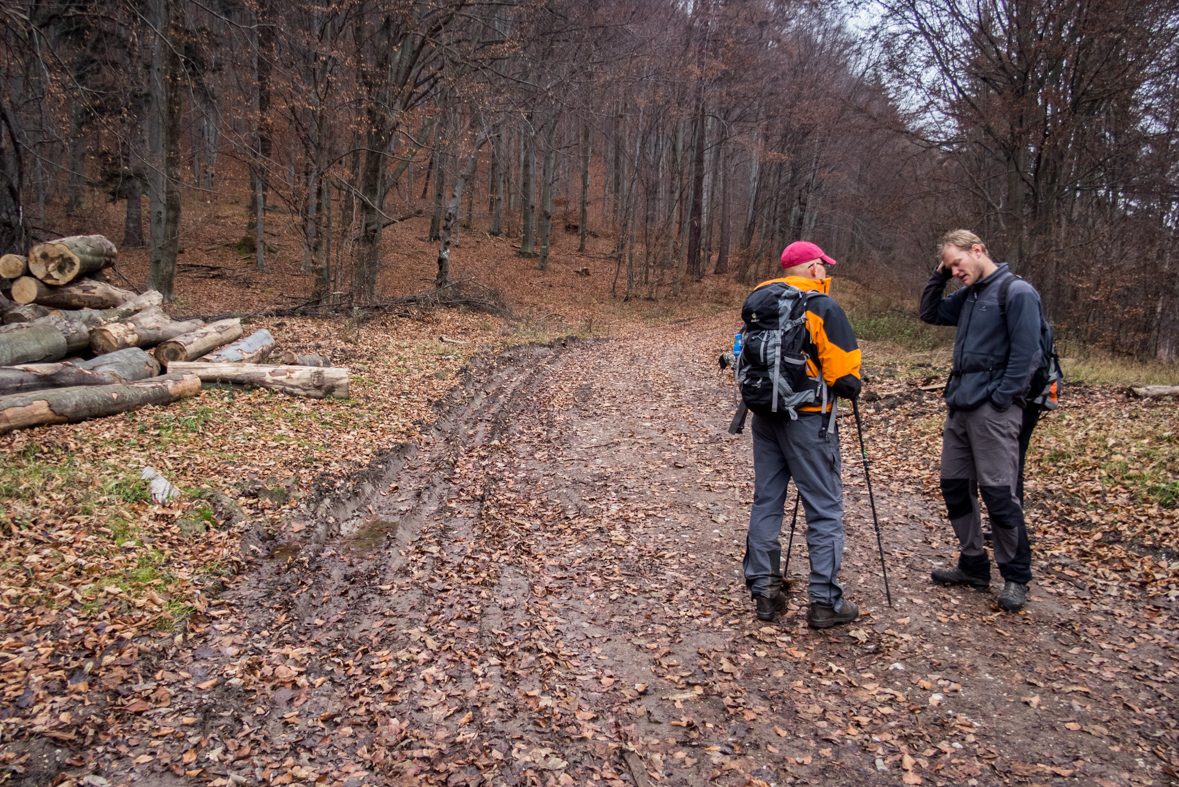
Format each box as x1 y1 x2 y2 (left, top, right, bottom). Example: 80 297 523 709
755 276 862 412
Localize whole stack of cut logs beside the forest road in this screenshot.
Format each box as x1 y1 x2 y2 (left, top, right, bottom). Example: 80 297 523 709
0 234 348 435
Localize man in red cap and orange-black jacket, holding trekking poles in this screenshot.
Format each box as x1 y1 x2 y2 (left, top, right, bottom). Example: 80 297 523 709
743 240 861 628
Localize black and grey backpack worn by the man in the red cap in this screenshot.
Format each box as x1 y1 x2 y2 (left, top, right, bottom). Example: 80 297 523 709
737 282 825 418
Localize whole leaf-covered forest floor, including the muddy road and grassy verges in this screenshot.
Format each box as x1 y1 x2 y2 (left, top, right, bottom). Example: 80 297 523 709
0 204 1179 787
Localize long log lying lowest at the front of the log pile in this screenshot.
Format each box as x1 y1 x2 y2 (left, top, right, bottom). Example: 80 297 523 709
0 375 200 435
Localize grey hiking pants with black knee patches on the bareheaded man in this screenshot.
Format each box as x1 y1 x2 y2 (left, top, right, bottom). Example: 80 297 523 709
941 404 1032 584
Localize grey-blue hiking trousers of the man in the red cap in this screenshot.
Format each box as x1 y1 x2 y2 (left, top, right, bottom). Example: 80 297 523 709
744 412 843 611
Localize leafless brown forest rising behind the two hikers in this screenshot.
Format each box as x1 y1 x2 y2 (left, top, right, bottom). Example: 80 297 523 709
0 0 1179 358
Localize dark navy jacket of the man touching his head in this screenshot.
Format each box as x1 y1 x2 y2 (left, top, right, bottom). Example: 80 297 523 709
921 263 1040 410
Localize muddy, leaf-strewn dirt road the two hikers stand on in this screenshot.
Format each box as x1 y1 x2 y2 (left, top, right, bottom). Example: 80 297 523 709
32 318 1179 787
